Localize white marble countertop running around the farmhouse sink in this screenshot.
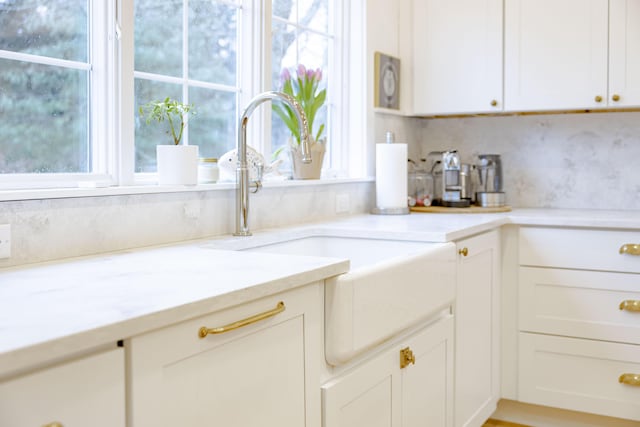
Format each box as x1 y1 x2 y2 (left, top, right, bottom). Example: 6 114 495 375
0 209 640 377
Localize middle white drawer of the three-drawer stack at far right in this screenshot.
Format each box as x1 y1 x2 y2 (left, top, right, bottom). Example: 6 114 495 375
518 267 640 344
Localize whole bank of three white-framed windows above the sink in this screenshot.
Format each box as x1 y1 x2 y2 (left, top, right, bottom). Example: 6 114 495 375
0 0 348 190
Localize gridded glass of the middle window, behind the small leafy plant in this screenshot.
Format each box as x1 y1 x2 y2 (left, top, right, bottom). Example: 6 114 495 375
134 0 241 172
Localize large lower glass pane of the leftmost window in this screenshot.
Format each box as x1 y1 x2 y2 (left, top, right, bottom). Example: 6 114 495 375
0 58 91 173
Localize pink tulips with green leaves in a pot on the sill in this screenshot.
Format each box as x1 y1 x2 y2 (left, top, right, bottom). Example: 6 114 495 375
272 65 327 179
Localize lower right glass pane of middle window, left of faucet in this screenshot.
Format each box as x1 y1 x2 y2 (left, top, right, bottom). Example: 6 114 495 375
189 87 237 158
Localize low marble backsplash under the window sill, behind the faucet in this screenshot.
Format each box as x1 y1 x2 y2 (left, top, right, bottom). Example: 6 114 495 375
0 182 375 268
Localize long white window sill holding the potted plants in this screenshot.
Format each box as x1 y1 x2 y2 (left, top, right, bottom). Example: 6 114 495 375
0 177 374 202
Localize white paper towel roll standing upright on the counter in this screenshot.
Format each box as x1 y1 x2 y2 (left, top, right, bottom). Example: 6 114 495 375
376 144 407 209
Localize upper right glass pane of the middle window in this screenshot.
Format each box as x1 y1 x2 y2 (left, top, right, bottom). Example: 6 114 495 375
189 0 238 86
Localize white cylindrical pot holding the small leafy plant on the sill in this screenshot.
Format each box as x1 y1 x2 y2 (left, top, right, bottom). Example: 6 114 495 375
156 145 198 185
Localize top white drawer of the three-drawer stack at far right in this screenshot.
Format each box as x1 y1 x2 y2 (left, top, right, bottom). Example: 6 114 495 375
519 227 640 273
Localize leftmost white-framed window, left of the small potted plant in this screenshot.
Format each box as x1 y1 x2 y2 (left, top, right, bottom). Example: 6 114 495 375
0 0 113 188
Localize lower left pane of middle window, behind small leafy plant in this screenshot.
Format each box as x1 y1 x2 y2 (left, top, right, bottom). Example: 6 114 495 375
135 79 181 172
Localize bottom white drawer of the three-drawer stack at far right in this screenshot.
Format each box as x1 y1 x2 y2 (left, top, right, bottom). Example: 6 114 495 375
518 333 640 420
